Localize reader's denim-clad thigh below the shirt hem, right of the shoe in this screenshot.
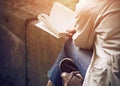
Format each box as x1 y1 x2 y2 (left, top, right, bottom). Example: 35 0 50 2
65 40 93 77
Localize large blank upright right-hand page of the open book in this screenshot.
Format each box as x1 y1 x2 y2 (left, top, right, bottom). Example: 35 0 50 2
49 3 75 32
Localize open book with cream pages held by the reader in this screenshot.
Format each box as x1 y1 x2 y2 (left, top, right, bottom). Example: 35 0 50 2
35 2 75 38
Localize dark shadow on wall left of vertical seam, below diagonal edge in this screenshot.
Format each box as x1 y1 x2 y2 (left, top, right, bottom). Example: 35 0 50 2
0 25 25 86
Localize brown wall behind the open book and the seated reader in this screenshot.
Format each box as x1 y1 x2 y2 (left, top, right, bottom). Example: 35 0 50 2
0 0 77 86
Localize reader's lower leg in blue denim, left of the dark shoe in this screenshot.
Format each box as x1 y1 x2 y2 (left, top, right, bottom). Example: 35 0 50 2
48 48 66 86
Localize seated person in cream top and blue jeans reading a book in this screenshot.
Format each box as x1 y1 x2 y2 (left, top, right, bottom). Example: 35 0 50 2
47 0 120 86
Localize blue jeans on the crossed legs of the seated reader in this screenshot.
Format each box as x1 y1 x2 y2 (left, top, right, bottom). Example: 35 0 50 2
48 40 93 86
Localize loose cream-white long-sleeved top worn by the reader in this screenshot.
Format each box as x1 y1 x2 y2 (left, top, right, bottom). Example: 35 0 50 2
73 0 120 86
